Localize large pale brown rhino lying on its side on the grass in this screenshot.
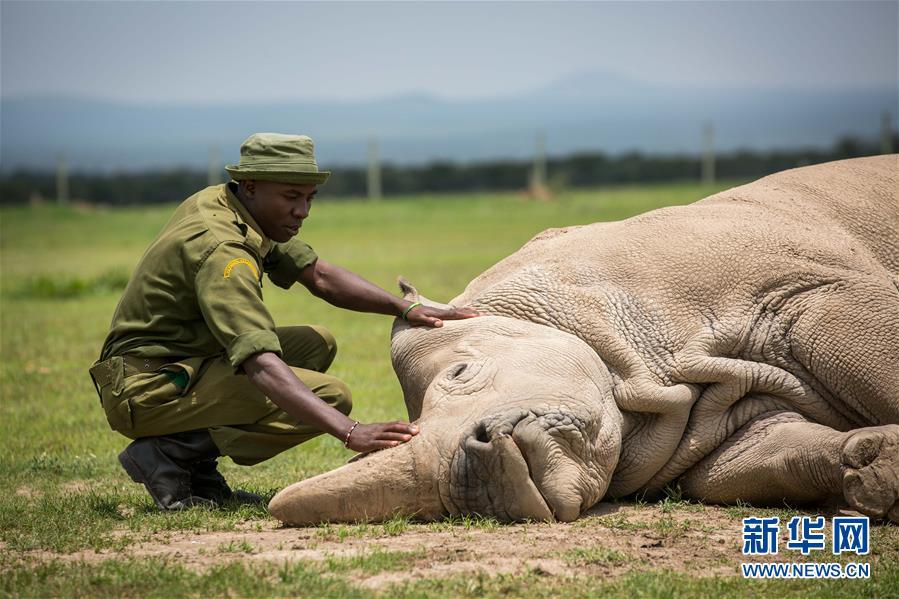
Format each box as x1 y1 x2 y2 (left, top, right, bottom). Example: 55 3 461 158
269 155 899 525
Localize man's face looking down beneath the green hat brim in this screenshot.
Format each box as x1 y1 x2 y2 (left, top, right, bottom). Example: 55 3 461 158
244 181 316 243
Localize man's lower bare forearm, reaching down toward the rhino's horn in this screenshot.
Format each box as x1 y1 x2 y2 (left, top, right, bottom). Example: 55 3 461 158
242 352 353 440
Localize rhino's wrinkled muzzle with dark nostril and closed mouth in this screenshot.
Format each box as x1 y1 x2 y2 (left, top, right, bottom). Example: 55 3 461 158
440 412 585 521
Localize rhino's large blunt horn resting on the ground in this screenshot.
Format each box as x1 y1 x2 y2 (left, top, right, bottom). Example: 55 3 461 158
268 436 445 526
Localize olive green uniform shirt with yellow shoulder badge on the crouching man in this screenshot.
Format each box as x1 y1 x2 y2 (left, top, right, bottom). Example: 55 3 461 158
101 185 317 367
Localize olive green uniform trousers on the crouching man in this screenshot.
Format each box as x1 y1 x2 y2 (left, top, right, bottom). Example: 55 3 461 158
91 326 352 465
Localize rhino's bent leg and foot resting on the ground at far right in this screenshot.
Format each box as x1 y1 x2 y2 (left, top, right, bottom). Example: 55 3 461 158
680 412 899 522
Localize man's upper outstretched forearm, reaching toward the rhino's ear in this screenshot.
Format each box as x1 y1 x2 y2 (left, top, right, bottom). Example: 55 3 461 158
301 260 410 316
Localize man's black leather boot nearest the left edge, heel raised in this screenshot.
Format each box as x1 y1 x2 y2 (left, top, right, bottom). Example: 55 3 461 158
119 431 219 510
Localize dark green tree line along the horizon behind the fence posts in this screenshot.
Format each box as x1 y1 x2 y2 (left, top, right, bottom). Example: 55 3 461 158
0 134 899 205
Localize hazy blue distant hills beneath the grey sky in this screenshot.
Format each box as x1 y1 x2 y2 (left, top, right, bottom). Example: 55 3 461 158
0 72 899 172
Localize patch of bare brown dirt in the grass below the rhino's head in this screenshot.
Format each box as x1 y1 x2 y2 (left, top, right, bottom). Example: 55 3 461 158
12 504 760 588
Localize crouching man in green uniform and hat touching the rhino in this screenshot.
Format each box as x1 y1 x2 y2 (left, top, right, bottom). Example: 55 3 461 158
90 133 475 510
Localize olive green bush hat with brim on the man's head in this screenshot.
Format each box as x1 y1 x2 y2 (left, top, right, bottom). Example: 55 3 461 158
225 133 331 185
